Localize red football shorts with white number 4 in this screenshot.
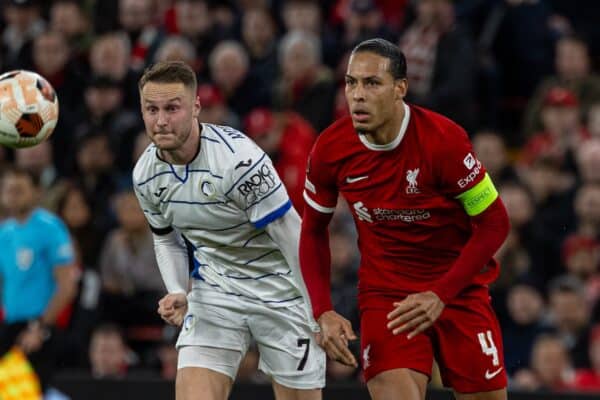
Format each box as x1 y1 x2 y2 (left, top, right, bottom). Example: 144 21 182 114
361 286 507 393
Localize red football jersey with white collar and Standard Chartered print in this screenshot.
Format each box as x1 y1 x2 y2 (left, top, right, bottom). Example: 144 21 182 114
304 105 498 307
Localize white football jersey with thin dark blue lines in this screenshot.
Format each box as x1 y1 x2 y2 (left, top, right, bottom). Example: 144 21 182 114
133 123 302 307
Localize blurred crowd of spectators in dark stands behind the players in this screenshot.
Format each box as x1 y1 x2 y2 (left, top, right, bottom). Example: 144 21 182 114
0 0 600 391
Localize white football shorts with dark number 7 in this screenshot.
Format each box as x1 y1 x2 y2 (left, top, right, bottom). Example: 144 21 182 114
177 288 326 389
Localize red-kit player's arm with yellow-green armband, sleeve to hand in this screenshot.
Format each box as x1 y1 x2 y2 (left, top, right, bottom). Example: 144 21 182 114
388 123 510 339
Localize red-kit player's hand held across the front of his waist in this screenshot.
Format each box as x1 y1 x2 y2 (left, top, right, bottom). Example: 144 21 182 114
387 291 445 339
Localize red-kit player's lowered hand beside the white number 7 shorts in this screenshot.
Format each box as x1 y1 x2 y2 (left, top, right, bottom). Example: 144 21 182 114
317 311 358 368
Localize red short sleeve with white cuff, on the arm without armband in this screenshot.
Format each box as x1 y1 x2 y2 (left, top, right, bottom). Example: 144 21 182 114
304 141 338 213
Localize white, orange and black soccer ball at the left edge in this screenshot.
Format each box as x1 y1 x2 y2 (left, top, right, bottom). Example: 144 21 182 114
0 70 58 147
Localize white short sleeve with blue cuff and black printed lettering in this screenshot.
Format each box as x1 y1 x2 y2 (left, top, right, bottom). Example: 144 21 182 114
224 143 292 228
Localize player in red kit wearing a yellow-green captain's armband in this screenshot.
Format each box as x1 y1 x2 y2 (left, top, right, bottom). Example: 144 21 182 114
300 39 509 400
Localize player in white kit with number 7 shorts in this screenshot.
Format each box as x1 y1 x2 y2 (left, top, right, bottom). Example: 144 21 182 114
133 62 326 400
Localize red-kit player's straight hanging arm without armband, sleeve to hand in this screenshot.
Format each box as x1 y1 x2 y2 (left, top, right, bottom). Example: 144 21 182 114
299 143 358 367
